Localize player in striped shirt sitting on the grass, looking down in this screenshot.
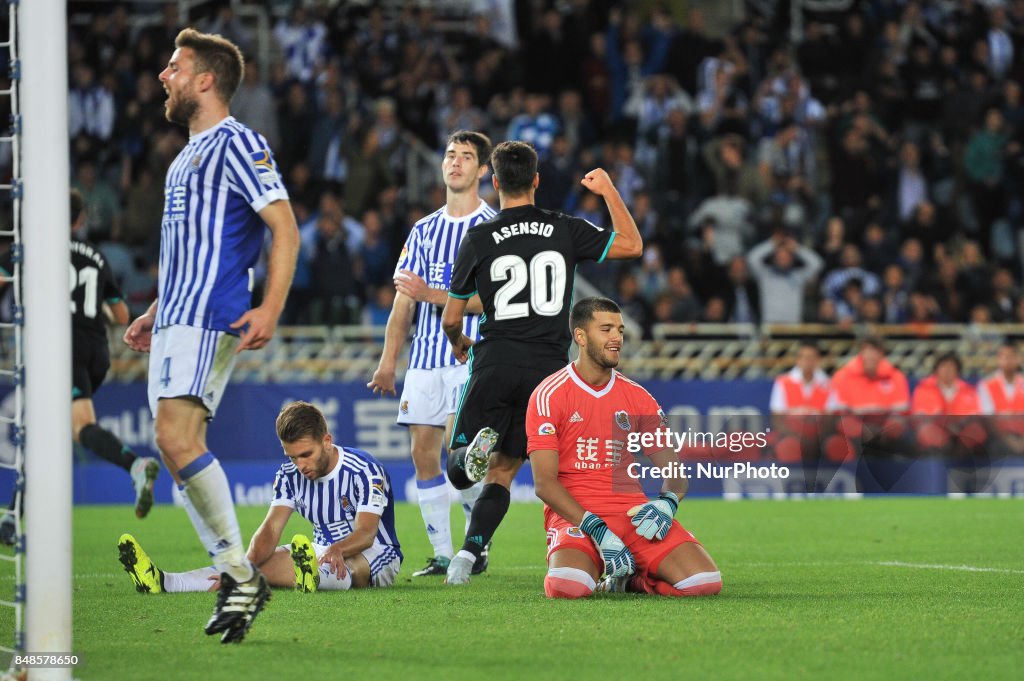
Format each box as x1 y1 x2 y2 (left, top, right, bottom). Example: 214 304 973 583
119 401 402 593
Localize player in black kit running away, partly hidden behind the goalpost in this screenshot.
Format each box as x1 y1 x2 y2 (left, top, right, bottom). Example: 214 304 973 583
0 189 160 544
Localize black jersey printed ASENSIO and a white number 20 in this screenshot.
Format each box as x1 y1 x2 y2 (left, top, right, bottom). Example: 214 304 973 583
449 206 614 367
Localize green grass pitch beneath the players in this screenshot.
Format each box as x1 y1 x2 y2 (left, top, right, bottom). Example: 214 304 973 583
0 499 1024 681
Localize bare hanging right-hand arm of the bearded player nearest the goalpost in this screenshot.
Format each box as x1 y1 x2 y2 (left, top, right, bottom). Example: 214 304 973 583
231 200 299 352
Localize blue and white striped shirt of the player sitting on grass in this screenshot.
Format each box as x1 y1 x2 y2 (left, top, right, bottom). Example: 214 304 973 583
270 444 402 559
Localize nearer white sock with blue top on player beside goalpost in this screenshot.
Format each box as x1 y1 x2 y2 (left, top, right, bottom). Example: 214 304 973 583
178 452 253 582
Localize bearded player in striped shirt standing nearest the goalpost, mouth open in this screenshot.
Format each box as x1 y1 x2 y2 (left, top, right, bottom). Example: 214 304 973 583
125 29 299 643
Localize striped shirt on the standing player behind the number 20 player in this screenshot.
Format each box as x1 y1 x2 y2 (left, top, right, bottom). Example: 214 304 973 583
394 201 497 369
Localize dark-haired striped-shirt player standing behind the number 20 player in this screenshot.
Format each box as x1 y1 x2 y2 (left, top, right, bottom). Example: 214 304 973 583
367 130 497 577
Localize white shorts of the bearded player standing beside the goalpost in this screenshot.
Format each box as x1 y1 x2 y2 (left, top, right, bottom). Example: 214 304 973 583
150 325 242 419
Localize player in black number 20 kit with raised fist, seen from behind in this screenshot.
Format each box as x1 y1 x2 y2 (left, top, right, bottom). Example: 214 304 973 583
441 141 643 584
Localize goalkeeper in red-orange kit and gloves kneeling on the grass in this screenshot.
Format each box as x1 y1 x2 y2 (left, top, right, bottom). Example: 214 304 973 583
526 298 722 598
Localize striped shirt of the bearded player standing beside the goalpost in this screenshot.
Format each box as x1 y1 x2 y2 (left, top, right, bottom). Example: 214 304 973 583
157 117 288 334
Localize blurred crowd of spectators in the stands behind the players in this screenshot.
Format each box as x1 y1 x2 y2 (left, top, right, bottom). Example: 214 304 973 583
22 0 1024 333
